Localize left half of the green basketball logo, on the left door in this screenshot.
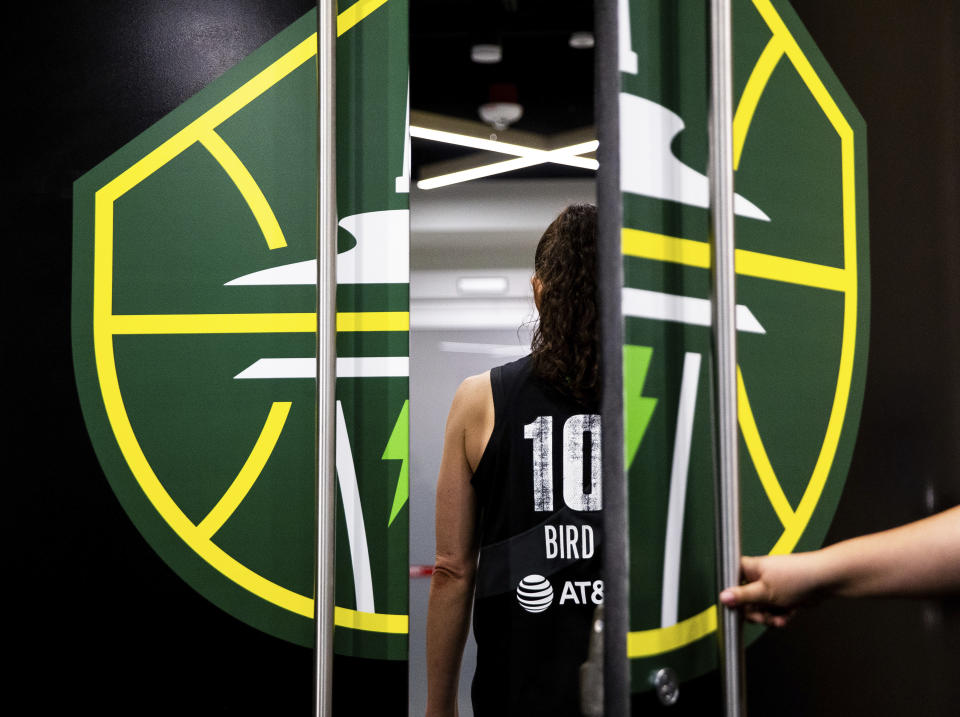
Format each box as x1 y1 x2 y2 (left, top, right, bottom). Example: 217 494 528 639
73 0 409 658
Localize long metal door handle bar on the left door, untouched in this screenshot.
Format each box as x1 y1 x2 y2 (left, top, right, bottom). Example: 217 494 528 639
313 0 337 717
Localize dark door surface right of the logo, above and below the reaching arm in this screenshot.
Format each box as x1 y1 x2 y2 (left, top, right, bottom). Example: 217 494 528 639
748 0 960 715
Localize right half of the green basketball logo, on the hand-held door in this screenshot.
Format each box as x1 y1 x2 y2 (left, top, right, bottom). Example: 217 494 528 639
620 0 869 691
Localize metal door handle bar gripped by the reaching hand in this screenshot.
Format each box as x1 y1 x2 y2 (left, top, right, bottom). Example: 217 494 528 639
709 0 745 717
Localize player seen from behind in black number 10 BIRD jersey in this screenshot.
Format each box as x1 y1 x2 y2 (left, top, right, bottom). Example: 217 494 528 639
427 204 603 717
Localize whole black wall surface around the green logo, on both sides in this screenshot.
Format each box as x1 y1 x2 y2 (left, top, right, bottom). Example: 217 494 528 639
11 0 960 716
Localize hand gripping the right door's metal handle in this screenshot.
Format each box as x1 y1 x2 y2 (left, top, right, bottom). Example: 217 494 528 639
720 553 820 627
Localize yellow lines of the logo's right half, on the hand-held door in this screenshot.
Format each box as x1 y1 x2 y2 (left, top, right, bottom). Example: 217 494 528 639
623 0 857 658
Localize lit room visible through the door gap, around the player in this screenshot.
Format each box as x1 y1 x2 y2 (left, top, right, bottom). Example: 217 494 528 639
409 0 596 715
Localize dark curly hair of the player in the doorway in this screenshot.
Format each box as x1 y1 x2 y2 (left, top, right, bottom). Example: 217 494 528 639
531 204 600 404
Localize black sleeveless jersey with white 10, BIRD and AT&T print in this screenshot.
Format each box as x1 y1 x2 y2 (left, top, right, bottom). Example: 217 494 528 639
472 356 603 717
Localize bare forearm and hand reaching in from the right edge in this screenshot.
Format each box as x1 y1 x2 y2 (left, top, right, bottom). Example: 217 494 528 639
720 506 960 627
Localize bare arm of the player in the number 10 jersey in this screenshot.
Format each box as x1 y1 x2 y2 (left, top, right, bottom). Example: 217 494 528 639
427 374 493 716
